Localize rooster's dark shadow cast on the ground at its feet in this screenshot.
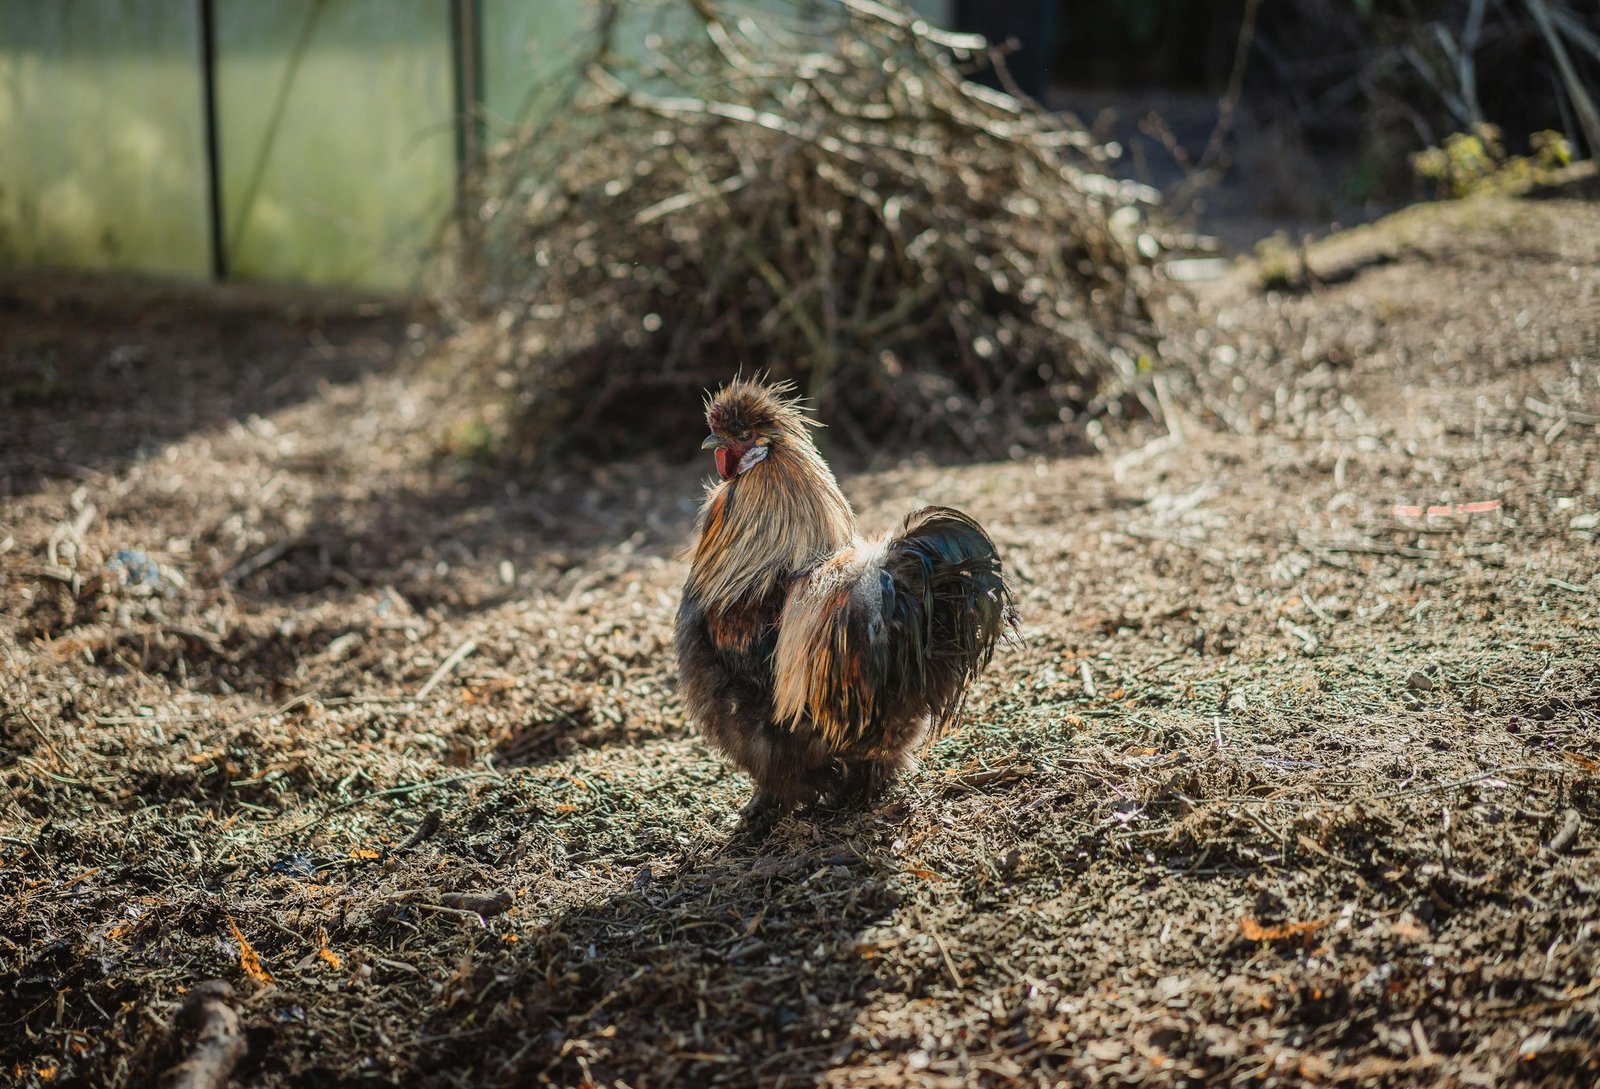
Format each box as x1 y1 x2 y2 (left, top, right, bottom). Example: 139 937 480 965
398 824 896 1086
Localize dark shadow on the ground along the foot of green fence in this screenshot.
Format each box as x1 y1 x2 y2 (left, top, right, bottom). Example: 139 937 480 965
0 281 414 497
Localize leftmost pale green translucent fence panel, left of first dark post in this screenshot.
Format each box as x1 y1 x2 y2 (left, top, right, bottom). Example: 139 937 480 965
0 0 211 277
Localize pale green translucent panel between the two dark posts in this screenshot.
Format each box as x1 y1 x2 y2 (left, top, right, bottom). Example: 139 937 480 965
216 0 458 289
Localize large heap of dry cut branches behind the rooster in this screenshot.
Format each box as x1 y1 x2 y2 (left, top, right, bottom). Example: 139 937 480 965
480 0 1166 456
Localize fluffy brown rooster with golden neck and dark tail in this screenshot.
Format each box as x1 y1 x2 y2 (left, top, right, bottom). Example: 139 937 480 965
675 379 1016 827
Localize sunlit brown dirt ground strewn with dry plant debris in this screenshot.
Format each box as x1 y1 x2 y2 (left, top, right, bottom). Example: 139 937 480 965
0 200 1600 1089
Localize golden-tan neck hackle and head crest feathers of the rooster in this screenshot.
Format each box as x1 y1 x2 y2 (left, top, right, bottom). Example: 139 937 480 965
688 381 856 611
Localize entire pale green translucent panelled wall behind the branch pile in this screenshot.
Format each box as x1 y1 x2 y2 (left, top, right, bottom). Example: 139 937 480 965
0 0 952 289
